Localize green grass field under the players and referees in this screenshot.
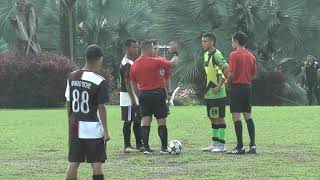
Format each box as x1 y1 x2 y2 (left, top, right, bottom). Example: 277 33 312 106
0 106 320 180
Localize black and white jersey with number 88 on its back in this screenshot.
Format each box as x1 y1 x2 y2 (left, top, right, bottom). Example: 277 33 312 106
65 70 109 139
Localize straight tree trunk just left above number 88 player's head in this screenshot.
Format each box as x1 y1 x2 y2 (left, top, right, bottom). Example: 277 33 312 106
60 0 76 60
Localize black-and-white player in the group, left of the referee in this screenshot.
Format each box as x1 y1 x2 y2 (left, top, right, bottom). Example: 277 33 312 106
120 39 143 153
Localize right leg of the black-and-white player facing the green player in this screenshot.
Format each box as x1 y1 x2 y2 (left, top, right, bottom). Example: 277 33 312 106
132 107 143 152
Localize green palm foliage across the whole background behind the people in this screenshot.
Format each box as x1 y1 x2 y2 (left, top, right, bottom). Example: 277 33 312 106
0 0 320 104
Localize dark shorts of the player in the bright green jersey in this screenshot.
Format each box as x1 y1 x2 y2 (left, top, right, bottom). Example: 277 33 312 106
207 98 227 119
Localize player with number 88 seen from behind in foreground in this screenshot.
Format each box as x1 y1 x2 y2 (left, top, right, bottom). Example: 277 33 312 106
65 45 110 180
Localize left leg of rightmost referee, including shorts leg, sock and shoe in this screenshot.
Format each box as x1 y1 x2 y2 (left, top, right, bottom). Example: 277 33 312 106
228 85 245 154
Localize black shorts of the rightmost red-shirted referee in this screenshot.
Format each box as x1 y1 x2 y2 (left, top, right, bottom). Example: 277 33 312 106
230 84 252 113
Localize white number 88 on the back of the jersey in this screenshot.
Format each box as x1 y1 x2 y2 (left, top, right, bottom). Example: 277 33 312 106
72 89 90 114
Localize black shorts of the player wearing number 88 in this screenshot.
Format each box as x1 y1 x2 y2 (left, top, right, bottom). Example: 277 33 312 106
68 137 107 163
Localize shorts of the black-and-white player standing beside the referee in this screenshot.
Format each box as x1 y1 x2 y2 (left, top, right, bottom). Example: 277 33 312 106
121 106 141 122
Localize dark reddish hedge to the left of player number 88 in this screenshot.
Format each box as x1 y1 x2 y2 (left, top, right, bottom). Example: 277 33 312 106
0 52 76 108
